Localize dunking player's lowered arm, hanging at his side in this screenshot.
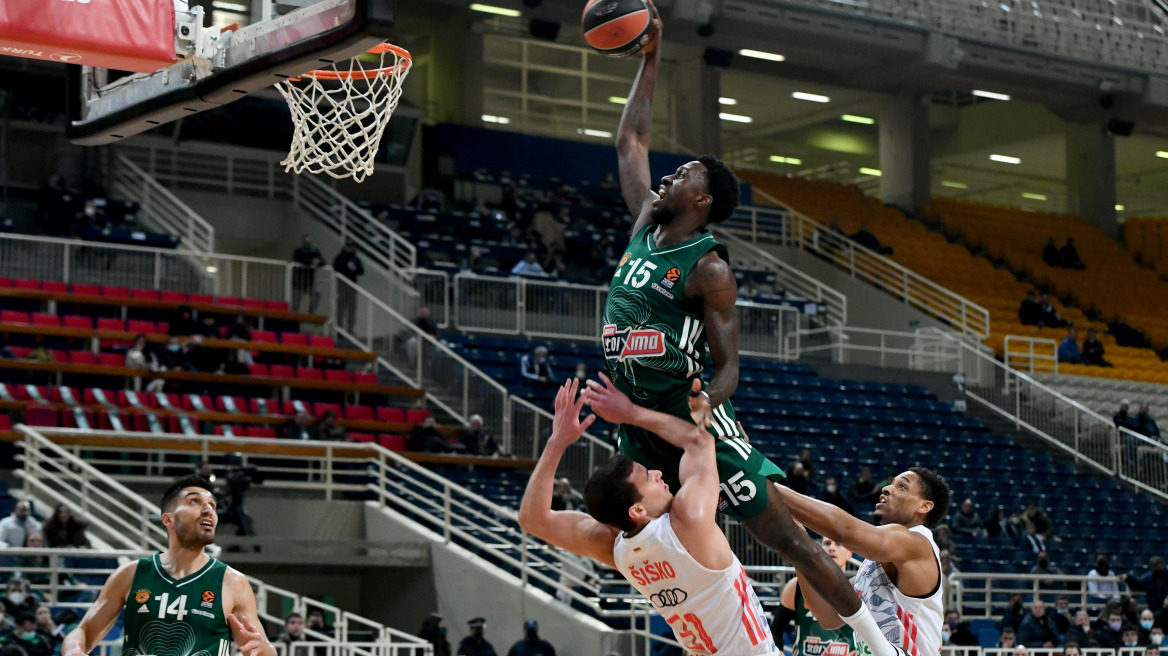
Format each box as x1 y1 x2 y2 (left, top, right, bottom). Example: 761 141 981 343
686 251 738 407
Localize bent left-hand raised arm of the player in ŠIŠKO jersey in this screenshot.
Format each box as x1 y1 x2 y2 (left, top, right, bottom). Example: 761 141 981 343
519 378 617 567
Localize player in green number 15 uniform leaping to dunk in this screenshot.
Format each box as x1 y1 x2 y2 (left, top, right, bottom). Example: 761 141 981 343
602 4 892 656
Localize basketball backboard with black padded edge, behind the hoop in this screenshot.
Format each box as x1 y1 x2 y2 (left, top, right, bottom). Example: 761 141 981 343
65 0 394 146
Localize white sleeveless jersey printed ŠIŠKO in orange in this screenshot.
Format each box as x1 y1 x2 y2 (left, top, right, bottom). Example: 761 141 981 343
612 512 783 656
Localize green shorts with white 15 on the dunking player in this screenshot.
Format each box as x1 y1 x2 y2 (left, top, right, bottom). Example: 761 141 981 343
618 402 786 522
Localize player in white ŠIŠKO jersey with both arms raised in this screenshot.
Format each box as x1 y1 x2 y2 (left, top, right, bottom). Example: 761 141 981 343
519 379 783 656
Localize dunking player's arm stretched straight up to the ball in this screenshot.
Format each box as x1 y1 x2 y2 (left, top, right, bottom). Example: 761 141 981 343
617 0 661 235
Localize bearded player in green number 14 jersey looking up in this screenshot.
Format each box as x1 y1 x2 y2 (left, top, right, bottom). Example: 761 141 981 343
61 475 276 656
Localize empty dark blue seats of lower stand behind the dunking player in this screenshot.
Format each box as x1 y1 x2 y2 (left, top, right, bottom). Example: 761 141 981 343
444 335 1168 573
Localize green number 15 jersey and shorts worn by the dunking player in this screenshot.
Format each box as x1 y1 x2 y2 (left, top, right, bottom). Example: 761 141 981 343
603 224 783 519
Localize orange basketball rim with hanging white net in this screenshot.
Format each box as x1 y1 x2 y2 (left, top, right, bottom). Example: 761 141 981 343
276 43 412 182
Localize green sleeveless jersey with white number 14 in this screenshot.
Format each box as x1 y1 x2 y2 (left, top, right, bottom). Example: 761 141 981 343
121 553 231 656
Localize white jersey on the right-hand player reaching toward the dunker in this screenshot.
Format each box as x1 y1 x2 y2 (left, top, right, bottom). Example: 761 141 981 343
854 526 945 656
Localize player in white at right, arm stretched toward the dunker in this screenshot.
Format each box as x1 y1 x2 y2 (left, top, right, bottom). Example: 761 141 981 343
780 467 950 656
